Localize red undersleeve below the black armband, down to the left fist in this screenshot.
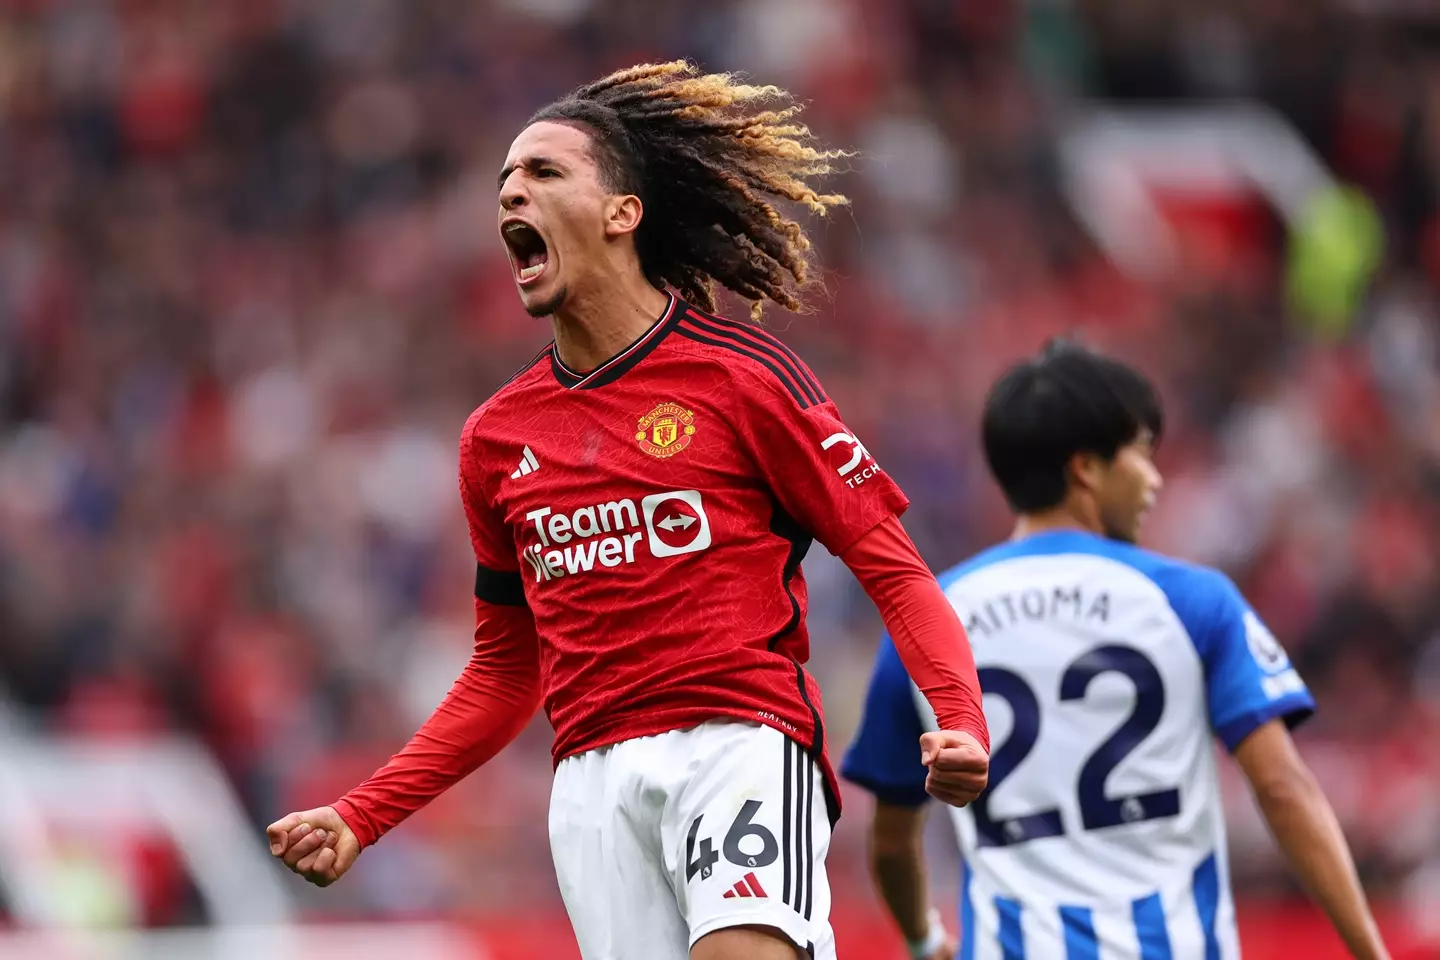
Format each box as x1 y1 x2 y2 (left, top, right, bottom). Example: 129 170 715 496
336 604 540 846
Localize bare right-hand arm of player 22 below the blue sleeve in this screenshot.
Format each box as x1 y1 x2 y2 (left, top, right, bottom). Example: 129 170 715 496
1234 720 1390 960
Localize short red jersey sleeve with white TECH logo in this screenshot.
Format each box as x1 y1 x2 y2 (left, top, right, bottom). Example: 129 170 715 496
736 352 910 556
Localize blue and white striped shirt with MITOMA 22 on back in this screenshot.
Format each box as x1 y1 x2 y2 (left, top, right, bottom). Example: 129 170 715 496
842 531 1315 960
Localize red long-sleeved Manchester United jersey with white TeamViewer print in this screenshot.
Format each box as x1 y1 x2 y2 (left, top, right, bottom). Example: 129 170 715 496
337 298 988 843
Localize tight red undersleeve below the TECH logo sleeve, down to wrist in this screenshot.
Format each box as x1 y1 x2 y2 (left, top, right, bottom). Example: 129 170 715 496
842 520 989 750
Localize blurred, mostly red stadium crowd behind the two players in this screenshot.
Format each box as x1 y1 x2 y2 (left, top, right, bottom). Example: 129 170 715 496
0 0 1440 923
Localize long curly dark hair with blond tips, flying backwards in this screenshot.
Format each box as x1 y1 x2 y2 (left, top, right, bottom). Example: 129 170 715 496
530 60 848 320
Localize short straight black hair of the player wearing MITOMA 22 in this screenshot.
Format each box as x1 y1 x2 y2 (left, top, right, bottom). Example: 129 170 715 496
981 340 1165 514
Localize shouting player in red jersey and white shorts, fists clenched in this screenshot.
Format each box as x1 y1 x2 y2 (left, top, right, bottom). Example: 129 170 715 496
269 60 989 960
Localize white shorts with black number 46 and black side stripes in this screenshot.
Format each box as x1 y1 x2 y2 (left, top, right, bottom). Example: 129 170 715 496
550 720 835 960
